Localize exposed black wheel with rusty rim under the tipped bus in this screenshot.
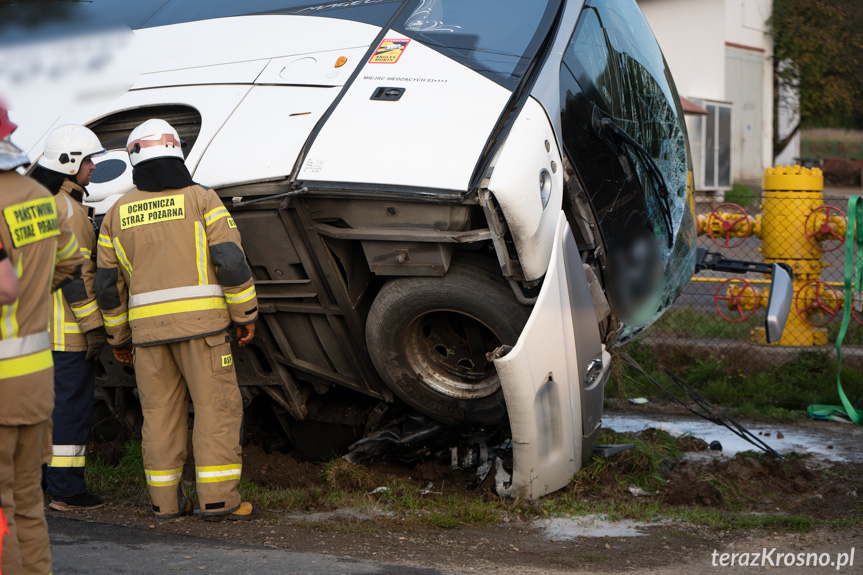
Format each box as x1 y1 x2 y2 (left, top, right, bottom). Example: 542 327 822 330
366 254 530 426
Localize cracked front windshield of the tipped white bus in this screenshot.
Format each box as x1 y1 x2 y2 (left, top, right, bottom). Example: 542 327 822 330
561 0 695 339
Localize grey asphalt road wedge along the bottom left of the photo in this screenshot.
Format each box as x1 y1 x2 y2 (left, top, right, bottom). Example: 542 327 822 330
48 517 446 575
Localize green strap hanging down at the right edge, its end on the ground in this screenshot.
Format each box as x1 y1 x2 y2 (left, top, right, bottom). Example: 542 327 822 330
806 196 863 425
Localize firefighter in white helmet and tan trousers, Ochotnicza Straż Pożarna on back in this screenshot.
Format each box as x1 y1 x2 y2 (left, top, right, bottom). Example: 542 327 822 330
96 120 258 519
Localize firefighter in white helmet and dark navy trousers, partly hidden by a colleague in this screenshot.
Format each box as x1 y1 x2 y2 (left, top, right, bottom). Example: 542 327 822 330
30 125 106 511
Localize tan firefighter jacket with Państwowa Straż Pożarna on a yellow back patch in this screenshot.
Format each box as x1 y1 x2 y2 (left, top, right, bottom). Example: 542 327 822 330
0 171 83 426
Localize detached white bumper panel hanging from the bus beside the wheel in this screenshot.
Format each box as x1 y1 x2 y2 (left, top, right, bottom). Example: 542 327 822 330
495 212 611 499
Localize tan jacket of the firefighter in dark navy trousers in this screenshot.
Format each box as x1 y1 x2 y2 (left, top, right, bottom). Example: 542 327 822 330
48 180 102 351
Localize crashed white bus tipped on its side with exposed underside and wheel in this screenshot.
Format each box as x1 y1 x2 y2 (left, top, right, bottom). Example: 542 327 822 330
5 0 695 497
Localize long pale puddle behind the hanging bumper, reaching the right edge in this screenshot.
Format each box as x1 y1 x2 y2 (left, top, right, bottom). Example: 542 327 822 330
602 413 863 462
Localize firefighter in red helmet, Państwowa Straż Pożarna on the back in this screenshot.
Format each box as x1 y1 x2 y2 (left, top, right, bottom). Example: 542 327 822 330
0 108 83 575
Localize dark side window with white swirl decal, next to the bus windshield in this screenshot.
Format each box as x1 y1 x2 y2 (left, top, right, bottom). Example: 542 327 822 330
395 0 560 90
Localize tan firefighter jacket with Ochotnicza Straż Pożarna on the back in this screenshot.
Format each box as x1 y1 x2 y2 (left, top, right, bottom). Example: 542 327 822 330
96 185 258 347
